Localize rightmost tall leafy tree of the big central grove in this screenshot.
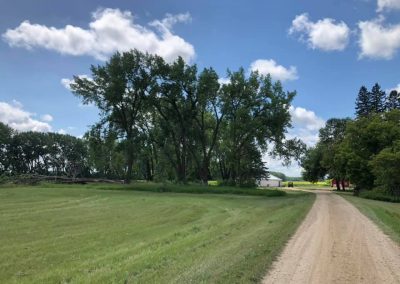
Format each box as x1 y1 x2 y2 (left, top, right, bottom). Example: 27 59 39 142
217 68 298 184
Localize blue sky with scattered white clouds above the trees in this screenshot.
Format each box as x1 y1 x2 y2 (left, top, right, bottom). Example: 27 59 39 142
0 0 400 175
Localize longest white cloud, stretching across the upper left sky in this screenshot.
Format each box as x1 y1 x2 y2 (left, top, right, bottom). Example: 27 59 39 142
3 9 195 61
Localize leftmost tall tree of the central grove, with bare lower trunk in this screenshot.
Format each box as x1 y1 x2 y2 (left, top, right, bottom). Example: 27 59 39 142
71 50 157 182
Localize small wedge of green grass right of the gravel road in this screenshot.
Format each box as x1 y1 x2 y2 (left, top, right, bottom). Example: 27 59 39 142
341 193 400 244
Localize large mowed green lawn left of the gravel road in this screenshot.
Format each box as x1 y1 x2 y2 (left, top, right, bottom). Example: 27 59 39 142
0 185 314 283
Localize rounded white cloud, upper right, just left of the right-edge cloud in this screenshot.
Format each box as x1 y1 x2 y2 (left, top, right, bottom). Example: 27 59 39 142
289 13 350 51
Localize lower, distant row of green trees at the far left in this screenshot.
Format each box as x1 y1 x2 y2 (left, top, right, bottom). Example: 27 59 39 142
0 123 88 177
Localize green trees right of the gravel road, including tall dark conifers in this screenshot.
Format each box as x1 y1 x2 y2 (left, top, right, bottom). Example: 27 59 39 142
302 84 400 196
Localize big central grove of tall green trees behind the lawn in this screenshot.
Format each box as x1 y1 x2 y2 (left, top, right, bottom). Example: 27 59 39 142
0 50 305 185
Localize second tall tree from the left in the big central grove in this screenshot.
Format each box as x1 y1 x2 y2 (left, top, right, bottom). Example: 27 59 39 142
152 57 198 182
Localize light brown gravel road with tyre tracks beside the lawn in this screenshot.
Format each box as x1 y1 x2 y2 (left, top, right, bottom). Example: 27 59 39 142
263 191 400 283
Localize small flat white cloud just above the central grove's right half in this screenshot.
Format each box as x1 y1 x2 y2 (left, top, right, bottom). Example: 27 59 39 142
250 59 299 82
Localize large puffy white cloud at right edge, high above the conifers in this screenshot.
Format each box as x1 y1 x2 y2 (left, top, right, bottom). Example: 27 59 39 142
358 17 400 60
